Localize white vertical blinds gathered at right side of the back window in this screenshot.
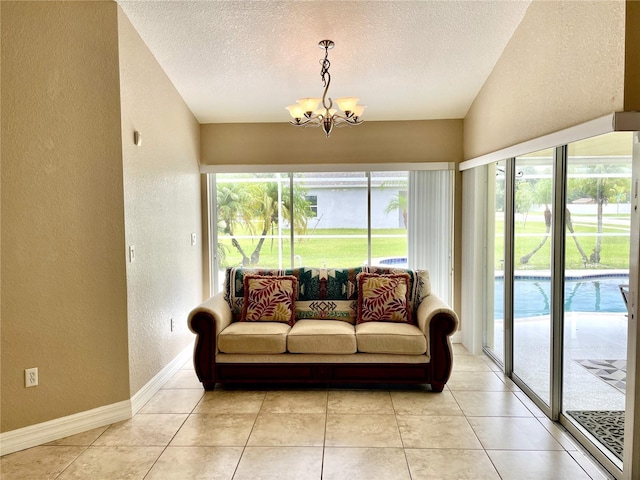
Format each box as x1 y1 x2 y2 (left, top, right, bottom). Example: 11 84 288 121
407 170 453 304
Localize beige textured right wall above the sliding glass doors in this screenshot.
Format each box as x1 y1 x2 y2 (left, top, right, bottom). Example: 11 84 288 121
464 0 638 159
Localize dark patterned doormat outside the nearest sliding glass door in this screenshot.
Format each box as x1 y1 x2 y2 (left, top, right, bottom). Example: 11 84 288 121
567 410 624 461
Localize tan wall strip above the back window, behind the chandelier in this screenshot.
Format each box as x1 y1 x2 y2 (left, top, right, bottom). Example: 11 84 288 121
201 120 462 165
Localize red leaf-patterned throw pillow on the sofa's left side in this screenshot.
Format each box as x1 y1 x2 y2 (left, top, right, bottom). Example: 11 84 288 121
240 275 298 325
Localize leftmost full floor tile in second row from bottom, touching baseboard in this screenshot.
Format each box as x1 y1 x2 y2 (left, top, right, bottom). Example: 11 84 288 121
93 413 188 446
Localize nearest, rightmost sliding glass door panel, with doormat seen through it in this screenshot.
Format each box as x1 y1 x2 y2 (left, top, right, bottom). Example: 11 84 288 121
562 132 633 466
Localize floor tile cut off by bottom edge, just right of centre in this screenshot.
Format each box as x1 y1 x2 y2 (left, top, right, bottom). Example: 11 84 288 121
322 447 411 480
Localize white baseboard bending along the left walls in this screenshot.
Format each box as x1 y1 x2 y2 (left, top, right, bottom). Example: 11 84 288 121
0 346 193 455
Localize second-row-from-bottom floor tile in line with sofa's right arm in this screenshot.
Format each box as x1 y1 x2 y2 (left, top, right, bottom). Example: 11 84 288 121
398 415 482 450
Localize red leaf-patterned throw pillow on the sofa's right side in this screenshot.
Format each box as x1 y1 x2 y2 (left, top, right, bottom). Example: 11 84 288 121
356 273 412 323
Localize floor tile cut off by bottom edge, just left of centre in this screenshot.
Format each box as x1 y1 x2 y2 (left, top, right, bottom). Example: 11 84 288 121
233 447 322 480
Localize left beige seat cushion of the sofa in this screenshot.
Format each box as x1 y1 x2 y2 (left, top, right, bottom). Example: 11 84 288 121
218 322 291 354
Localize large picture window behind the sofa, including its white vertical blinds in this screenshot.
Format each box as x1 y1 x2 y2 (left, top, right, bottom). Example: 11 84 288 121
209 171 453 299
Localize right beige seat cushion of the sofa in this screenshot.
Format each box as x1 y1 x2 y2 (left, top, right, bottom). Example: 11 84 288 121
356 322 427 355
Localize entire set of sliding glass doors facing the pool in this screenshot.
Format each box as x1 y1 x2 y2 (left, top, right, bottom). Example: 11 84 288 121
482 132 634 471
